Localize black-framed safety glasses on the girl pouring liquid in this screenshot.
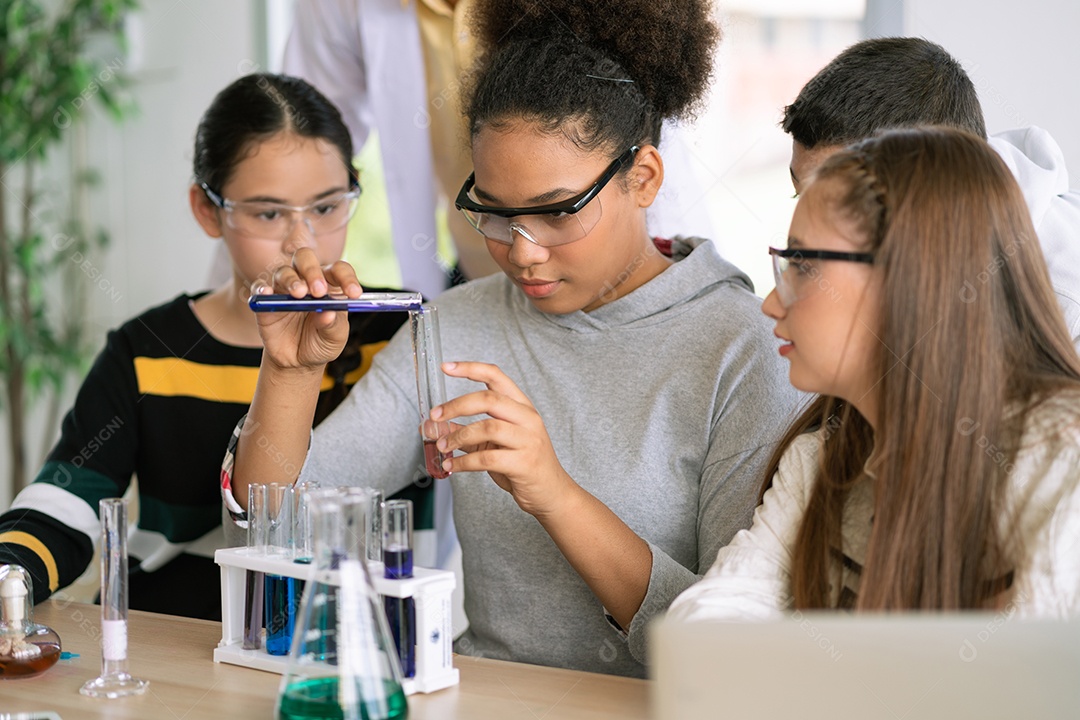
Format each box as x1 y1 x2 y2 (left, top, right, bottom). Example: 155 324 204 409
454 145 640 247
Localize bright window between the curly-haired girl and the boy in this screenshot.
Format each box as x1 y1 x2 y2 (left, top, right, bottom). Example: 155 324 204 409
692 0 866 296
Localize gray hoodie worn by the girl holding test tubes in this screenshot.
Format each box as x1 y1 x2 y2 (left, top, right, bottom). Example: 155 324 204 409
300 241 799 677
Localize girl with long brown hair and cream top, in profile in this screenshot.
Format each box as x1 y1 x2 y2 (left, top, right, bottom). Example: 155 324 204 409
671 128 1080 620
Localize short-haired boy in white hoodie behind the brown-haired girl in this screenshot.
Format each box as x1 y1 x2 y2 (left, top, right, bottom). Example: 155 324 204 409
781 38 1080 349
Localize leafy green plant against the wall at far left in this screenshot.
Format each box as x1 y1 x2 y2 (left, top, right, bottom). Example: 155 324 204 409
0 0 136 492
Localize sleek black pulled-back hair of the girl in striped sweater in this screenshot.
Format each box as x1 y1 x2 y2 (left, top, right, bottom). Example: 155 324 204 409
193 72 356 192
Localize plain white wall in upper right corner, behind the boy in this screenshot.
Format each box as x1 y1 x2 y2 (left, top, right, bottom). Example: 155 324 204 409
903 0 1080 172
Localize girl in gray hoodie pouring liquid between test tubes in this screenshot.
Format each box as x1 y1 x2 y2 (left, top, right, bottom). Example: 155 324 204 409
222 0 797 676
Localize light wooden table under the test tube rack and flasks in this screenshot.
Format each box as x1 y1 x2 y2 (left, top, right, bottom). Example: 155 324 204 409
0 601 648 720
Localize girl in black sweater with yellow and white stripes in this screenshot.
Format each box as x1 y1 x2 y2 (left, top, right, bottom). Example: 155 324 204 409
0 74 404 620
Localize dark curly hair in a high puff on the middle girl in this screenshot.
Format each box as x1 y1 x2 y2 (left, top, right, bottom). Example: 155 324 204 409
462 0 720 158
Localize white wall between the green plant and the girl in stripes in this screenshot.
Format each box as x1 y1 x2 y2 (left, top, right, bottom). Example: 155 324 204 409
0 0 265 508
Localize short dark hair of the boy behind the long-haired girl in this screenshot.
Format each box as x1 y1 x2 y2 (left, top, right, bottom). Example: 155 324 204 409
781 38 986 148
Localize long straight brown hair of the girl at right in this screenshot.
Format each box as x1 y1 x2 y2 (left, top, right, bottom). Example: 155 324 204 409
765 127 1080 610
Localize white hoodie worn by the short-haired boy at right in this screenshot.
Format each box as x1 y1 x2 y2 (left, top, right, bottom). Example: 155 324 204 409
990 126 1080 350
